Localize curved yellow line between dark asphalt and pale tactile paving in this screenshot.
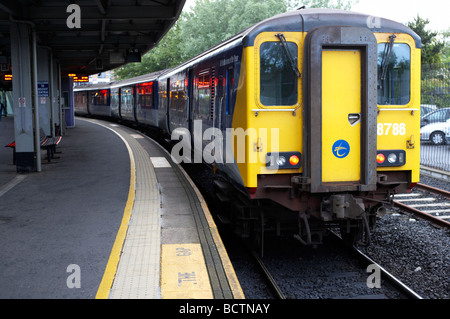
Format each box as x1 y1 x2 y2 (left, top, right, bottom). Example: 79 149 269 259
90 123 136 299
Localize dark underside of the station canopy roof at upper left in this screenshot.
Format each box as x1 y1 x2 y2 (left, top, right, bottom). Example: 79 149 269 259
0 0 185 75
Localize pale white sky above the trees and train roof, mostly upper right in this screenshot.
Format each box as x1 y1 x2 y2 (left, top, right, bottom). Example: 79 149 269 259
185 0 450 31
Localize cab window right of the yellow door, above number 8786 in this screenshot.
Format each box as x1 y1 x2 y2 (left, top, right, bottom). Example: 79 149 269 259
377 43 411 105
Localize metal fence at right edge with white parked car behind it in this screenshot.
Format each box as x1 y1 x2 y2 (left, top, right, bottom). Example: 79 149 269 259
420 63 450 172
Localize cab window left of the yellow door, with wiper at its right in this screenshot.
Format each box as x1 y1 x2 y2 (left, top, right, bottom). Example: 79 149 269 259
260 42 298 106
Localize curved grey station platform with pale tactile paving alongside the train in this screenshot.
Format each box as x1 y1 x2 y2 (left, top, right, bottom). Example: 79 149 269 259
0 117 244 299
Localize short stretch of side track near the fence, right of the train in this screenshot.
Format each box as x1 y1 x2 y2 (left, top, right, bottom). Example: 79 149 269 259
394 184 450 228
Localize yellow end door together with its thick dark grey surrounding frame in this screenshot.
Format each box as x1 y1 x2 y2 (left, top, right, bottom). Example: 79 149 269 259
303 27 377 193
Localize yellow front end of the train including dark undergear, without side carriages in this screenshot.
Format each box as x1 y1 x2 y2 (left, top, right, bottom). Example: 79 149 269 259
216 9 421 244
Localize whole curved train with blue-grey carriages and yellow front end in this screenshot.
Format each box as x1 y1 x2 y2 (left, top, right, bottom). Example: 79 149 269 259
74 8 421 245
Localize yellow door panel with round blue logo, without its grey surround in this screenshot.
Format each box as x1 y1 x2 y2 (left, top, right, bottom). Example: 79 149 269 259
322 49 362 183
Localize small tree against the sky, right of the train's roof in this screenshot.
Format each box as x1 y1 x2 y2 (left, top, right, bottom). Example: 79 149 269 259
408 15 444 64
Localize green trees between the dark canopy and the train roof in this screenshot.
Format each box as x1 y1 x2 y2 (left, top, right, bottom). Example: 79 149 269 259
115 0 357 79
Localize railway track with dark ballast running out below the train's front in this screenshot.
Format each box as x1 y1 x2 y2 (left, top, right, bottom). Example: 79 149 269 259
246 236 422 299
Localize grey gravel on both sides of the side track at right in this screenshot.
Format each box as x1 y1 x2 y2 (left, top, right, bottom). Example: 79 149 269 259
362 176 450 299
